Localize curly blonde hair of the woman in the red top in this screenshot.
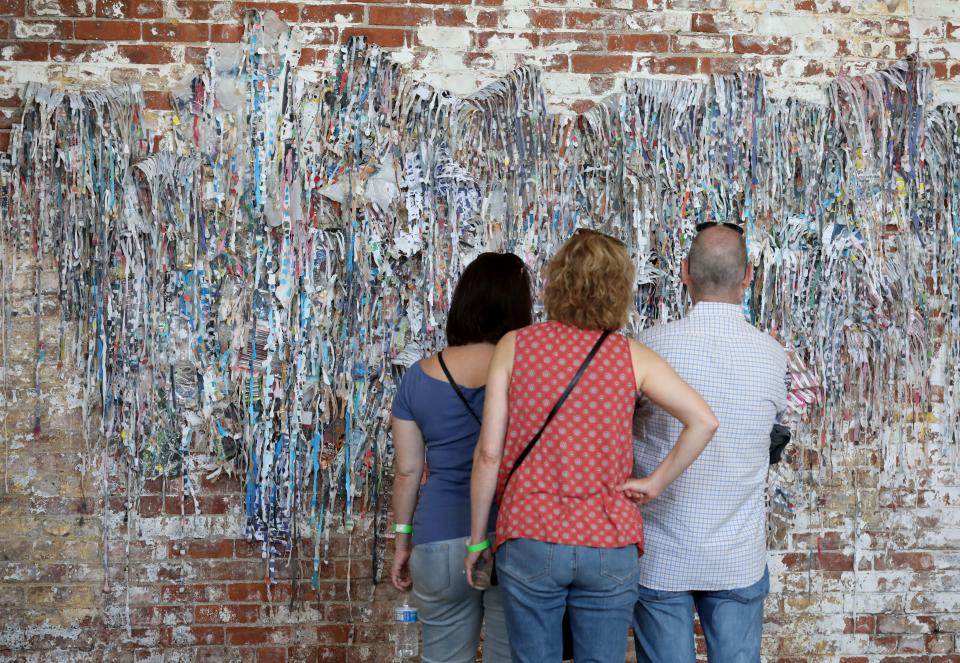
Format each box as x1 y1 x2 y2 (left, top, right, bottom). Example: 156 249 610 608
543 230 635 330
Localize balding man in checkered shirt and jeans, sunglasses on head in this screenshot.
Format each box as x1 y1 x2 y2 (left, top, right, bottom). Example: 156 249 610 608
633 223 787 663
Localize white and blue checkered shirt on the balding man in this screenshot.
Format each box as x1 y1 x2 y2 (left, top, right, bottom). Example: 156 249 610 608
633 302 787 591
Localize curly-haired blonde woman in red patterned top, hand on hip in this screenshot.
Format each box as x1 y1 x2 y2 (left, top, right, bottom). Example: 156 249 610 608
464 230 718 663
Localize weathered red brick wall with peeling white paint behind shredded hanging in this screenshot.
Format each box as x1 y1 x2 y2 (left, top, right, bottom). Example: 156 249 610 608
0 0 960 663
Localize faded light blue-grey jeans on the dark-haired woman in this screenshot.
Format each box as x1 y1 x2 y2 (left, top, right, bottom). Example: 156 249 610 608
410 538 510 663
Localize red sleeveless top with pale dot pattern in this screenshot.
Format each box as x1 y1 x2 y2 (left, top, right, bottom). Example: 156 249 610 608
496 321 643 552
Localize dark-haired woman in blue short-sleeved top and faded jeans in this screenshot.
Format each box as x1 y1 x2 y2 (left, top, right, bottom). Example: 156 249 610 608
391 253 533 663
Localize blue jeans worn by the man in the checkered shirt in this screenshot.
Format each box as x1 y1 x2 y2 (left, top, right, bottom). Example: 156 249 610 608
633 570 770 663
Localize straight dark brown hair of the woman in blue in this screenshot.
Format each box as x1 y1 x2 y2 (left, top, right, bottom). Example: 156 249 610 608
447 253 533 345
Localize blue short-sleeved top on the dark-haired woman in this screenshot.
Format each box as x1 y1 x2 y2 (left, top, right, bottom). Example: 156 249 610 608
393 362 497 546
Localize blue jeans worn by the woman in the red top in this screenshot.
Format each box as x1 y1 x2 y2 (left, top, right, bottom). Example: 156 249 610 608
497 539 640 663
